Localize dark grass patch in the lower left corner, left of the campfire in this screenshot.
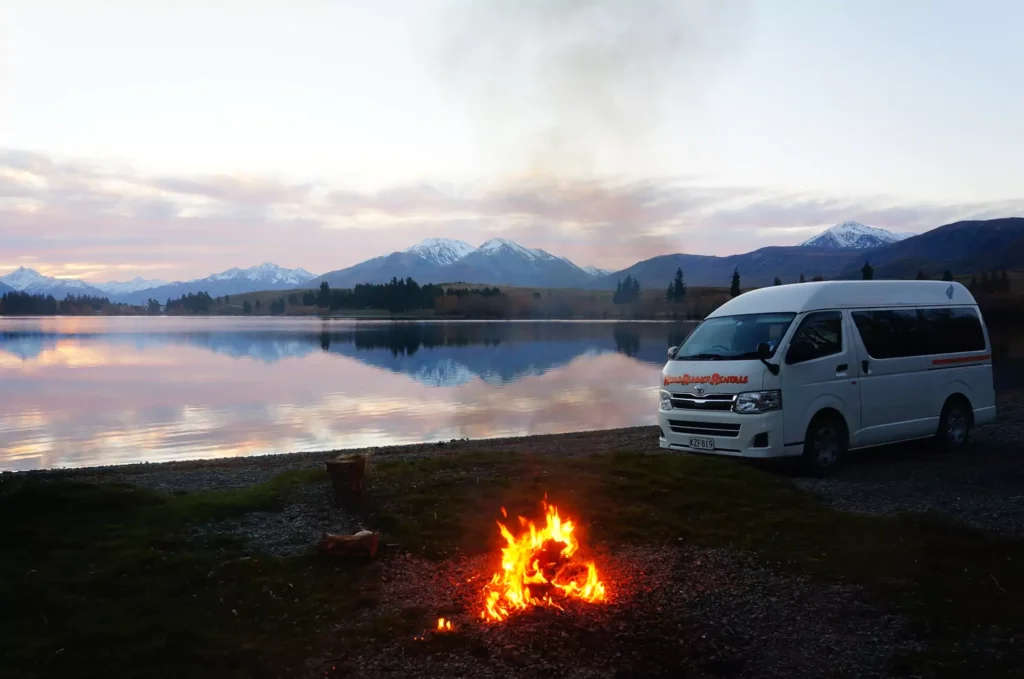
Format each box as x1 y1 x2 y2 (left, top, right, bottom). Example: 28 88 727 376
0 477 376 677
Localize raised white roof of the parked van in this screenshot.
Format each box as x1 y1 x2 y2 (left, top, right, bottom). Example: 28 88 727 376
708 281 976 317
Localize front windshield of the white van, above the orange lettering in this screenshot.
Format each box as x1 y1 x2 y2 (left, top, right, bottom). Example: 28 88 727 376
674 313 797 360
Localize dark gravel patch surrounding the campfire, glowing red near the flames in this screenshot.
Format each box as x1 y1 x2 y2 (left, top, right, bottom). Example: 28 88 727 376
309 545 915 678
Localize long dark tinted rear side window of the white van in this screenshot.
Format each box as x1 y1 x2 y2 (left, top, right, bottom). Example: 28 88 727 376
853 307 985 358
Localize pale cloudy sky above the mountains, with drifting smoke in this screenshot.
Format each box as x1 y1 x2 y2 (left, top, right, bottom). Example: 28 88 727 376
0 0 1024 282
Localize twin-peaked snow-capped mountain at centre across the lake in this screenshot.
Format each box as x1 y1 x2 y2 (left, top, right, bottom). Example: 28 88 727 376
312 238 594 288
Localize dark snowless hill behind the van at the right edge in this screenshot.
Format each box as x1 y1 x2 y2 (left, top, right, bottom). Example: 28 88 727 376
841 217 1024 279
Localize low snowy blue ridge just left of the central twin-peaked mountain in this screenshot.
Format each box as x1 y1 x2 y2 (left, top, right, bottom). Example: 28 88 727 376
112 262 316 304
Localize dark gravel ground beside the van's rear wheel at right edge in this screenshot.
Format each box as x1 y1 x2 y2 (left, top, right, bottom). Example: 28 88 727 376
793 394 1024 537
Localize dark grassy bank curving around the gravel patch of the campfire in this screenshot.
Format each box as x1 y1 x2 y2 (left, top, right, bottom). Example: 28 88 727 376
0 448 1024 678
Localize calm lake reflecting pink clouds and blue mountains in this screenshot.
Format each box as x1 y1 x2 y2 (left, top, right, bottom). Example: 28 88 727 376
0 316 1024 470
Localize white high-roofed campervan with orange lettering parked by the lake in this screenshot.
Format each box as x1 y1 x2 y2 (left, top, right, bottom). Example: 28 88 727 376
658 281 995 473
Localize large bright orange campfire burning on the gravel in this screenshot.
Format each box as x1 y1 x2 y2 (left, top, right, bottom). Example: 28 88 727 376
480 501 604 622
